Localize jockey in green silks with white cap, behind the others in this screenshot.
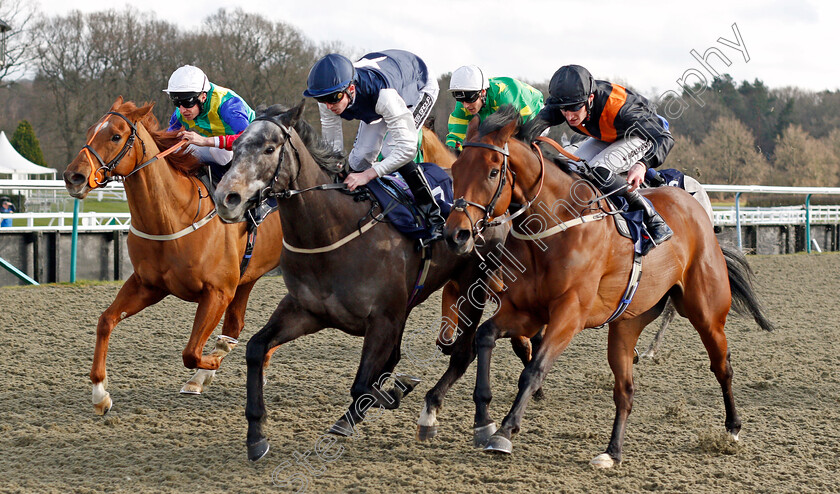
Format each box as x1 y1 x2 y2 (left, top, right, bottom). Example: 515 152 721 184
446 65 543 151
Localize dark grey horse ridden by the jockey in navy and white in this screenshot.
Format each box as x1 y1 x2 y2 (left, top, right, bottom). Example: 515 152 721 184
215 102 507 461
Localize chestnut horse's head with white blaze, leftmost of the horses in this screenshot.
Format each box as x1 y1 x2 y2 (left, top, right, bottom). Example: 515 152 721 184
64 97 154 199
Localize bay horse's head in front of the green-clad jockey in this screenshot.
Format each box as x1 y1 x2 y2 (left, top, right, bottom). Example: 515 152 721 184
445 106 521 254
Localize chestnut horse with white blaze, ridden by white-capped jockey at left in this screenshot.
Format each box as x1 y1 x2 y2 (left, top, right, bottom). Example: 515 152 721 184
64 97 283 415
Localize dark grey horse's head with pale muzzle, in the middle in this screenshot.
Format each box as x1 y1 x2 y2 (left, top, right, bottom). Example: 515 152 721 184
215 101 304 222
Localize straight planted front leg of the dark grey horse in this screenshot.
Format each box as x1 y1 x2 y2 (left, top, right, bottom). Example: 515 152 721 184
245 295 323 461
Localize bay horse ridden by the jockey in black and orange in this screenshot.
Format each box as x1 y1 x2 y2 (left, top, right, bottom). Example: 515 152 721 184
445 107 773 468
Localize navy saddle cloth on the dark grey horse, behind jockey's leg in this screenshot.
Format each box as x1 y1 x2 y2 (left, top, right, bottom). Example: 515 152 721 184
367 163 454 239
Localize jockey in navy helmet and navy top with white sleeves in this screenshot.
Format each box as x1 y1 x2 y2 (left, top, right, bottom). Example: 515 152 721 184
303 50 444 238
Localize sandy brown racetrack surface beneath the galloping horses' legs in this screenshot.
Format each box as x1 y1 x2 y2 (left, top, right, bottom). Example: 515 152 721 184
0 254 840 493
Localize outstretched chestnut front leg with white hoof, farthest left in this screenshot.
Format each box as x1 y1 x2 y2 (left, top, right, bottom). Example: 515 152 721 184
90 274 167 415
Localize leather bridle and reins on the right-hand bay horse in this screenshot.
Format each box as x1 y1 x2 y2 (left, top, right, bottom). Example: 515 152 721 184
452 142 545 238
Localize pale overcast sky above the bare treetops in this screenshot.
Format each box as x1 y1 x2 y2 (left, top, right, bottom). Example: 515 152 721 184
27 0 840 96
